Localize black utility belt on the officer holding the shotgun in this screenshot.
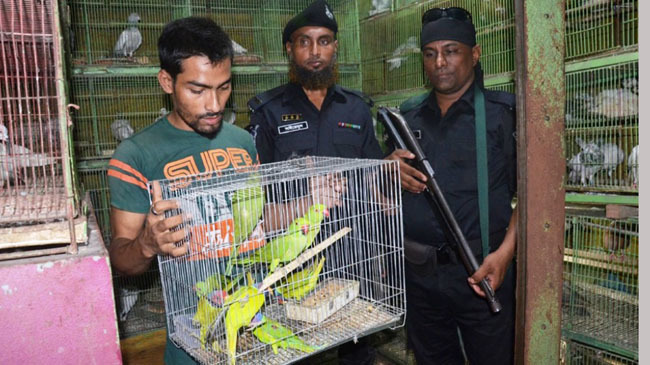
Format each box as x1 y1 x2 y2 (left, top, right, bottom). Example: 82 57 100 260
404 229 506 265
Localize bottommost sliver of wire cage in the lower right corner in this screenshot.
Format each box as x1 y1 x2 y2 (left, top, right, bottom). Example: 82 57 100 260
560 339 639 365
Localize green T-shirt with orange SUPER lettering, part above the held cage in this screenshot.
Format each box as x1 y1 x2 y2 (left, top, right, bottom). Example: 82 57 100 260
108 117 258 214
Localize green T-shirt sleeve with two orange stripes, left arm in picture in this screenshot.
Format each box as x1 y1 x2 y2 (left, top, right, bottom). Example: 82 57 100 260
107 140 150 214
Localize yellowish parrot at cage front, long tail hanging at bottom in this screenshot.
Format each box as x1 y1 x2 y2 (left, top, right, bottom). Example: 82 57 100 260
224 273 264 364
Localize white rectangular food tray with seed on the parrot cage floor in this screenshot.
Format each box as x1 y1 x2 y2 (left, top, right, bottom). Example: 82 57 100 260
285 278 359 324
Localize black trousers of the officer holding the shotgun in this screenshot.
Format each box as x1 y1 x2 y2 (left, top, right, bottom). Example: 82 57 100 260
406 255 515 365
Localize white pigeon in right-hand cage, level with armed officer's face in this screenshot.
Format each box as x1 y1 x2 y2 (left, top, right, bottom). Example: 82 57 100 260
589 78 639 118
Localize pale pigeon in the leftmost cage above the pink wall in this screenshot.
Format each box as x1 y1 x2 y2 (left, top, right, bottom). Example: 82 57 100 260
0 124 56 186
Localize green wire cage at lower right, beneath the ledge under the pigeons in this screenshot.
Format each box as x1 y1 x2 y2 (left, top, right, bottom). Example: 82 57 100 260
562 214 639 358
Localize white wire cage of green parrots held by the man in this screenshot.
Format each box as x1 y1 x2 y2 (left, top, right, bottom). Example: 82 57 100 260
150 157 405 364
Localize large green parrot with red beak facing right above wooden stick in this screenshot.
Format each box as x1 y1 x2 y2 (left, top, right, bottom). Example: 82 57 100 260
237 204 329 272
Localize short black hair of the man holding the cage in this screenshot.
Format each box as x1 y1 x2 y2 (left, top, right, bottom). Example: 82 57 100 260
158 17 233 79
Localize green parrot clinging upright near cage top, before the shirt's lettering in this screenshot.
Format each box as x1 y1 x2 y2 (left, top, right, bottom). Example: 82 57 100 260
226 175 266 275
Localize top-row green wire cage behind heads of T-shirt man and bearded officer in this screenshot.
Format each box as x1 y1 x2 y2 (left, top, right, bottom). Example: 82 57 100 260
68 0 359 65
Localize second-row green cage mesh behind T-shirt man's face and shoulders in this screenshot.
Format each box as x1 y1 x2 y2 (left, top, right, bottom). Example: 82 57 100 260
71 67 361 159
